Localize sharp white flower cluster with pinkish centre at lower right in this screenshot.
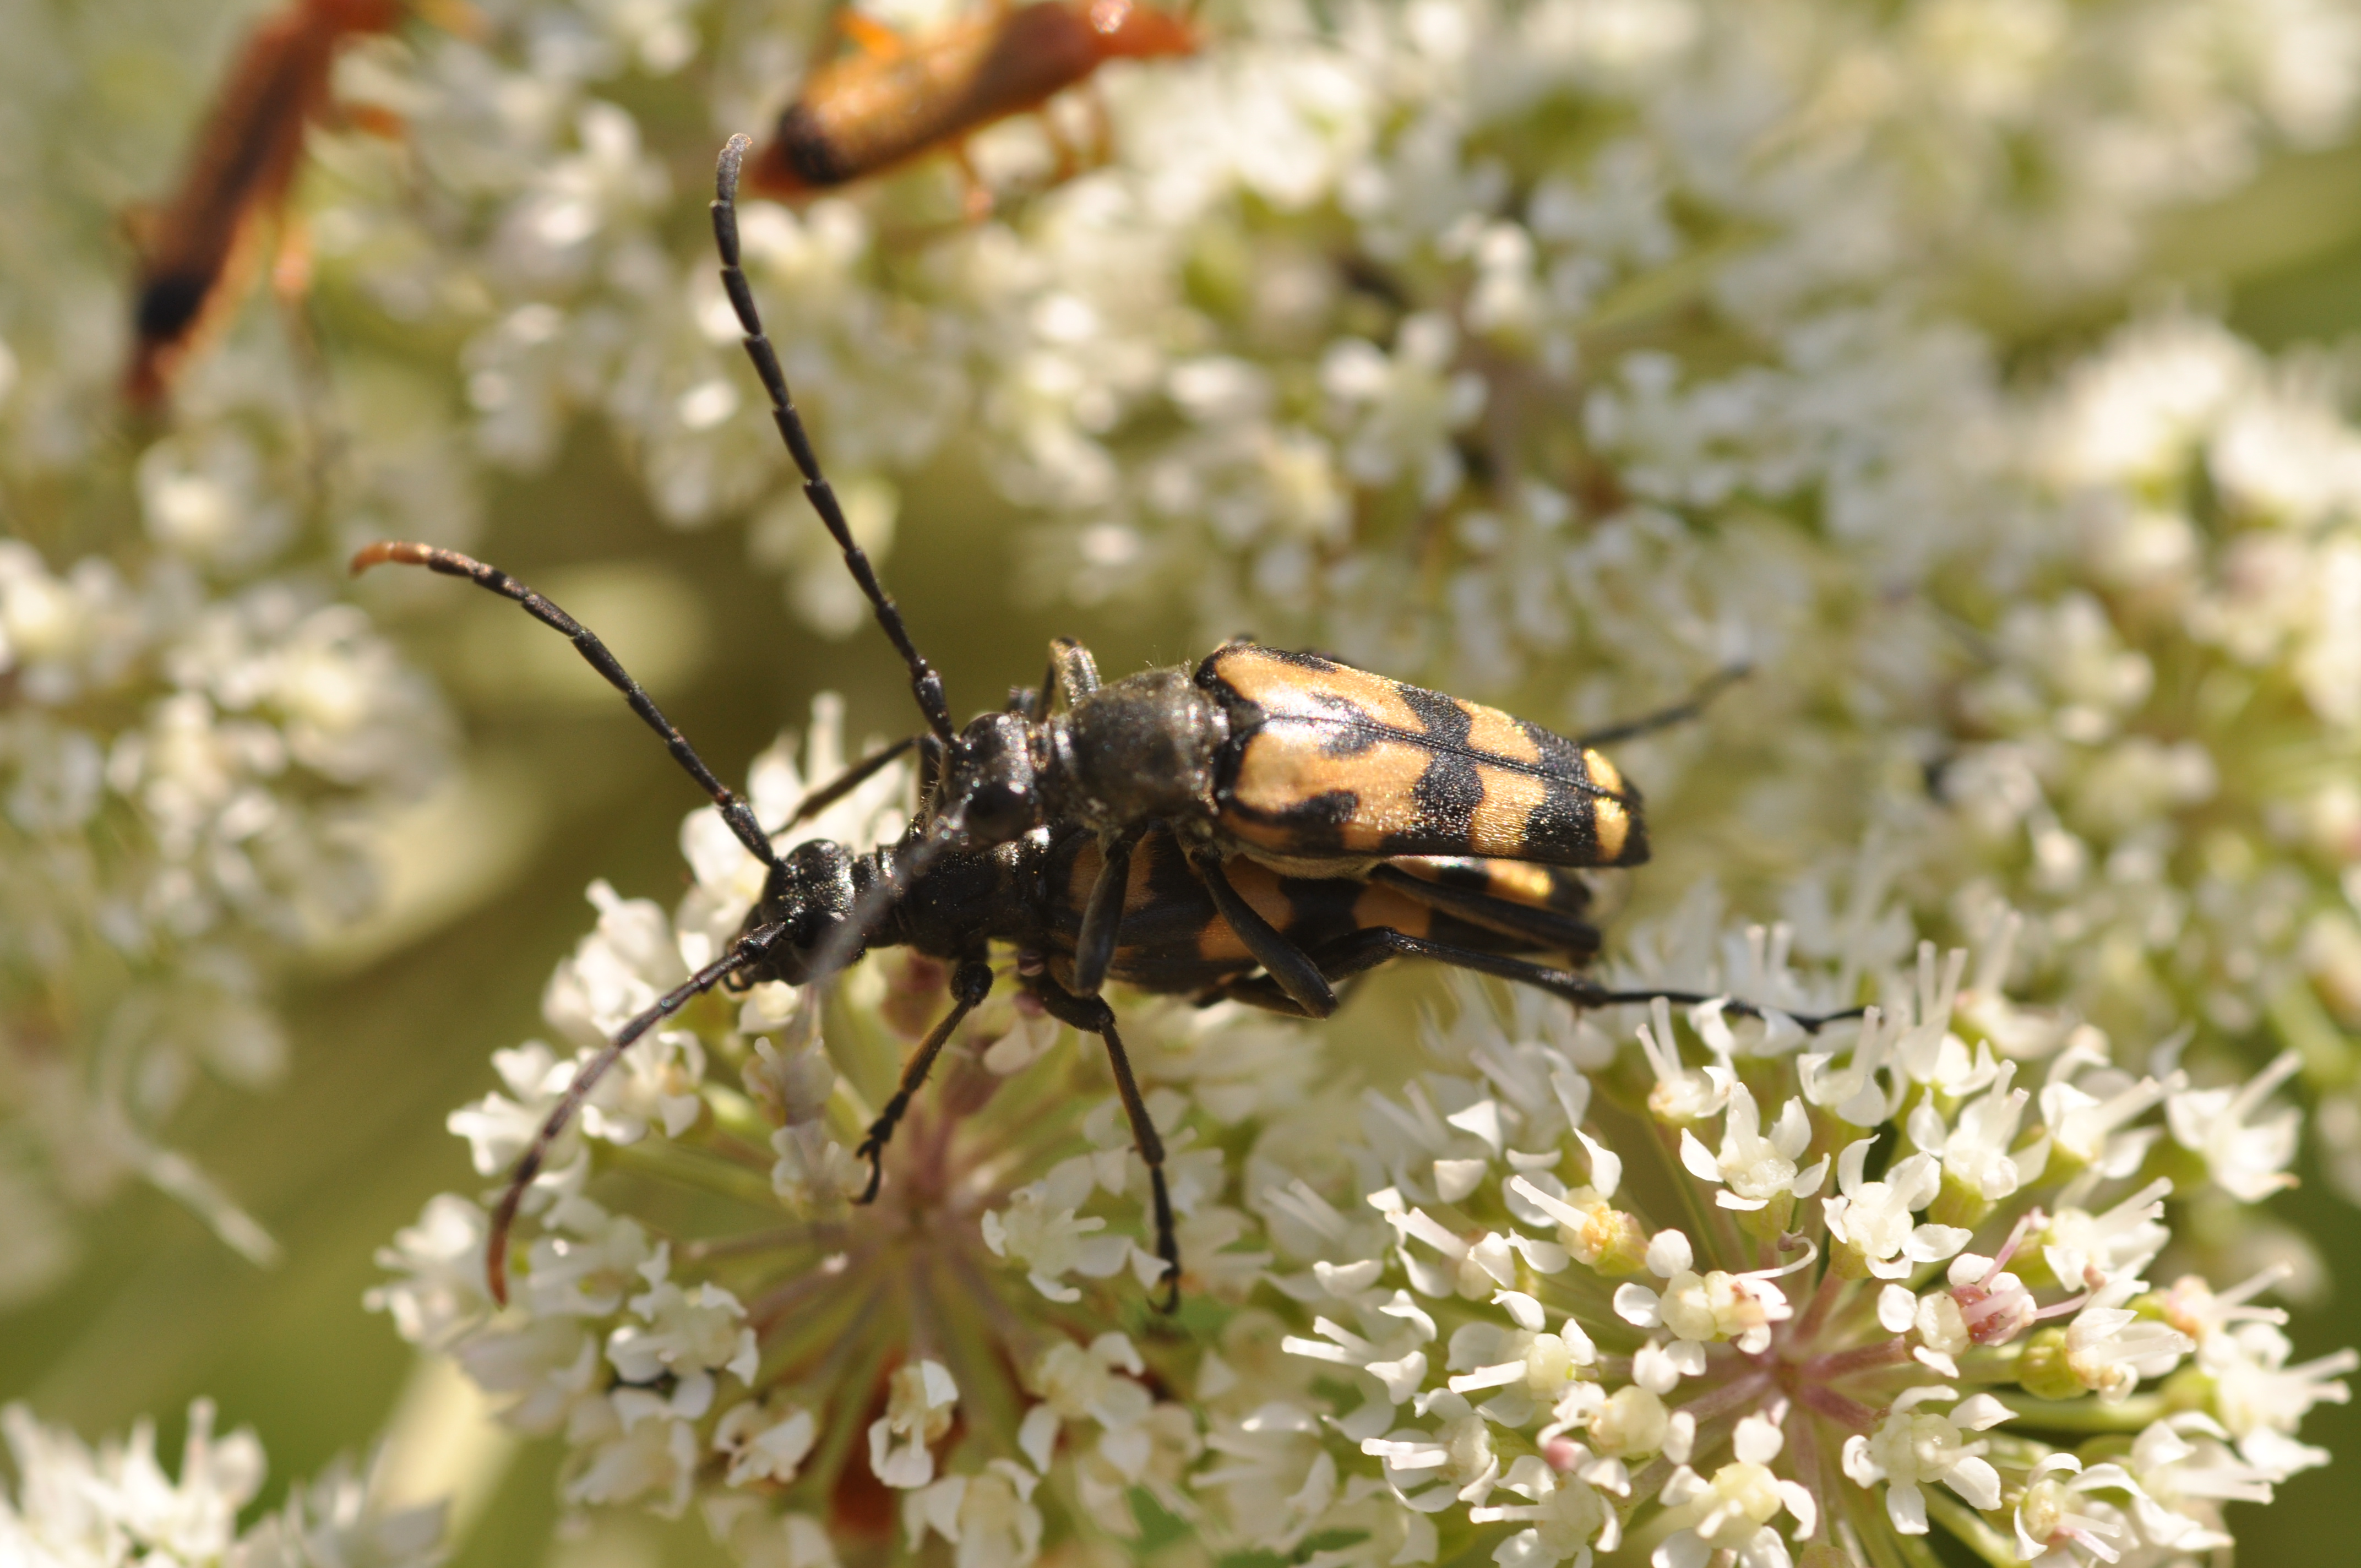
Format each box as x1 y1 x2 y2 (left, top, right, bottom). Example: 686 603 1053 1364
1259 902 2361 1568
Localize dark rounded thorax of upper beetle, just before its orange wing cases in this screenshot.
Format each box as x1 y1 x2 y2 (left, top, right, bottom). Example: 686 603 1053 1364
1041 668 1230 831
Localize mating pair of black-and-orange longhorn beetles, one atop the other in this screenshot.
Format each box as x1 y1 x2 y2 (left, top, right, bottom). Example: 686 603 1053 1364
352 137 1827 1299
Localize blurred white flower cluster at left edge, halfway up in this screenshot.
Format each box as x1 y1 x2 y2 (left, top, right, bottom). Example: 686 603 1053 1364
0 439 444 1301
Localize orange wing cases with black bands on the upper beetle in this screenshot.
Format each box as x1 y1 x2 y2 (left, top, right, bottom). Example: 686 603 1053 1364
1197 645 1648 867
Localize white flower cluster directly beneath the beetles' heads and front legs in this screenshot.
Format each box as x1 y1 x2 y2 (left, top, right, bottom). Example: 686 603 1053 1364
371 699 1318 1568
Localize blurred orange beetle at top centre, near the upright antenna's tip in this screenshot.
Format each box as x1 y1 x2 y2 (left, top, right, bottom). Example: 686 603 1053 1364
746 0 1197 210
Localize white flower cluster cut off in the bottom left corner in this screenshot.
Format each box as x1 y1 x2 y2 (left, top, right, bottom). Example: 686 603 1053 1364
0 1400 444 1568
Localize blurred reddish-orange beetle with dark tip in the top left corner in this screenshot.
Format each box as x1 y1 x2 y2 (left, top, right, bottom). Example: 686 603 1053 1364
123 0 451 409
